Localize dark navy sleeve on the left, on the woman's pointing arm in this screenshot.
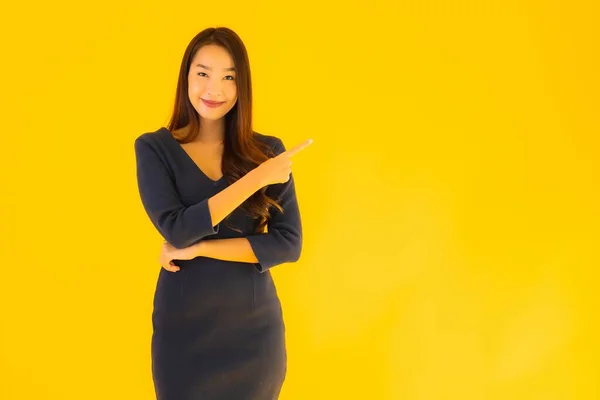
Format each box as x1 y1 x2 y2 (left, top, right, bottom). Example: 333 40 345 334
134 136 219 248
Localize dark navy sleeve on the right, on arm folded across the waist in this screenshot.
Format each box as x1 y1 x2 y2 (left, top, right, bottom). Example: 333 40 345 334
246 139 302 272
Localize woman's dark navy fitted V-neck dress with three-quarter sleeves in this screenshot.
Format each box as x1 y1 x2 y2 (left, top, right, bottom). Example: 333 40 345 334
134 127 302 400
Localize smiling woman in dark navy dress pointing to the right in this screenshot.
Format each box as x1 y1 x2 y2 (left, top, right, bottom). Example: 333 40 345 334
135 27 312 400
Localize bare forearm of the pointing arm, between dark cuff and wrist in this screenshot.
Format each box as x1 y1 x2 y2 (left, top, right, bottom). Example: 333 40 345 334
208 170 264 230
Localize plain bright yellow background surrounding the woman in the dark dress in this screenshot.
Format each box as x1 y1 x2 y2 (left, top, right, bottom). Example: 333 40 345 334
0 0 600 400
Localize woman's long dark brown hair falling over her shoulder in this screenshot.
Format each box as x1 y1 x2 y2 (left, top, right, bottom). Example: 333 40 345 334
167 27 282 233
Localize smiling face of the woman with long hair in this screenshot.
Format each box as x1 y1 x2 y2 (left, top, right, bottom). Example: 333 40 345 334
188 44 237 120
